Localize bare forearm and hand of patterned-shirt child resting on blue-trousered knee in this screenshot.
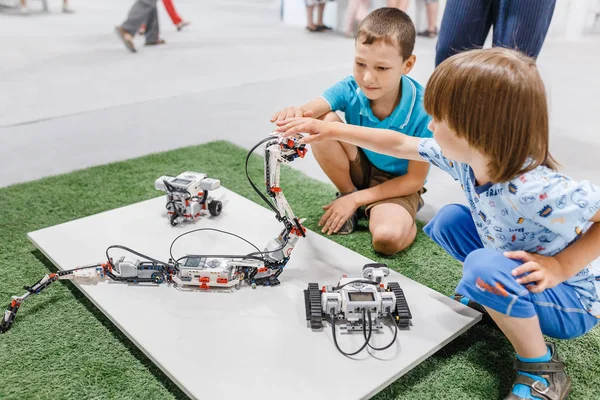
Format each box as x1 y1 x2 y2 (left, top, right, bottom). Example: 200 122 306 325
505 211 600 293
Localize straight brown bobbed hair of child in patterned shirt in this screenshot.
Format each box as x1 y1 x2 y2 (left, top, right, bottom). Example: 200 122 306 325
424 47 556 182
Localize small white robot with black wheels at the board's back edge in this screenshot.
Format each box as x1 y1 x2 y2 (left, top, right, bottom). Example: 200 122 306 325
154 171 223 226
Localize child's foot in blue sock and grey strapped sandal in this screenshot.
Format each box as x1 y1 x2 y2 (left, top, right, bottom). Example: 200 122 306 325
505 343 571 400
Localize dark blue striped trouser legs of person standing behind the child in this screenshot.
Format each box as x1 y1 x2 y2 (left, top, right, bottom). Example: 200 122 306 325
435 0 556 66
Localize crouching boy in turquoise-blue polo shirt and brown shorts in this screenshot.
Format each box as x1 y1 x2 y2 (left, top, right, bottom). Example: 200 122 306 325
271 8 432 255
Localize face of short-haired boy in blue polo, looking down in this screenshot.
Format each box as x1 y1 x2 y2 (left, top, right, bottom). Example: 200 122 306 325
354 38 415 100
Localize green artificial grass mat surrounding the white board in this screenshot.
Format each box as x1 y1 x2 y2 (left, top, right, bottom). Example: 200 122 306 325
0 142 600 400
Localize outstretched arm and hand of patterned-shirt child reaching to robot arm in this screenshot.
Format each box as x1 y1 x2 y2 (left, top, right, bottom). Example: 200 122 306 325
276 118 423 161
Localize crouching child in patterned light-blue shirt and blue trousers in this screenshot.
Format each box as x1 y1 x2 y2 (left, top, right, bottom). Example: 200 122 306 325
279 48 600 400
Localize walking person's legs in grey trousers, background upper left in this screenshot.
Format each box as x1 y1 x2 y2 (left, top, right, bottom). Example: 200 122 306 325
115 0 165 53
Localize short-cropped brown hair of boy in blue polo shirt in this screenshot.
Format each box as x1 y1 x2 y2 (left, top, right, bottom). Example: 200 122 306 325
356 7 416 60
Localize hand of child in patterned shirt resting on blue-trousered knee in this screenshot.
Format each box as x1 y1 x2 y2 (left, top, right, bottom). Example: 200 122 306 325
504 250 567 293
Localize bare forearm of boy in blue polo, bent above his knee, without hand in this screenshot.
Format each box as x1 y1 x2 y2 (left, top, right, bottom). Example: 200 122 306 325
353 161 429 207
